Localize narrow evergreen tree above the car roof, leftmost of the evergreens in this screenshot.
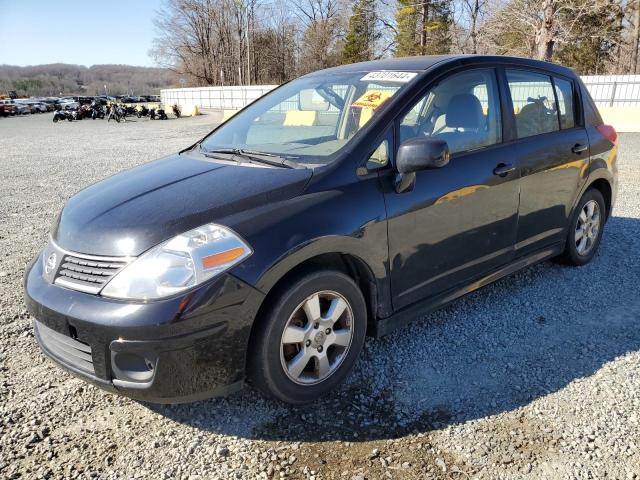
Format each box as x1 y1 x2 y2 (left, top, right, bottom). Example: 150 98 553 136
342 0 379 63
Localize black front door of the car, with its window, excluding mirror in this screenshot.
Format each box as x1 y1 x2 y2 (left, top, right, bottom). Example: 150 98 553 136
385 68 519 309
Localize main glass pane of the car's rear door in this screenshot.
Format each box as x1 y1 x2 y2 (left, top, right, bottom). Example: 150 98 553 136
507 70 560 138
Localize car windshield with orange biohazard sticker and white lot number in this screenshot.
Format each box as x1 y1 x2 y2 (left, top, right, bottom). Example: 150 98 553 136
201 71 417 165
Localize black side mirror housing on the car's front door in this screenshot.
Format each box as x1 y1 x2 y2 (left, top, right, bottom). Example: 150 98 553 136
396 137 449 174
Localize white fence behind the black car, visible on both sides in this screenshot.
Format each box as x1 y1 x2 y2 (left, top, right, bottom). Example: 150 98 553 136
160 75 640 110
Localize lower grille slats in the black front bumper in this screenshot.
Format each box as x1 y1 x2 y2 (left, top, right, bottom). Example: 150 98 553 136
34 320 95 375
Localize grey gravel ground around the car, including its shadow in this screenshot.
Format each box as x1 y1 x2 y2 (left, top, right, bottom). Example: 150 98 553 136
0 115 640 480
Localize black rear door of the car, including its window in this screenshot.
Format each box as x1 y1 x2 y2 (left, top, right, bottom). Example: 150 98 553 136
505 69 589 256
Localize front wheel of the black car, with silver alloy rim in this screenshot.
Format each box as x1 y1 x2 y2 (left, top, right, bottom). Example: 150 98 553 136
248 270 367 405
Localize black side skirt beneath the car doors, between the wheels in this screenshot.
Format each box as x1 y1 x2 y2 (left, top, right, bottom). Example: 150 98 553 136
373 244 564 338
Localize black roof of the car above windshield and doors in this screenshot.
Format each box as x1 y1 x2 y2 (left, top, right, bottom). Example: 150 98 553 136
310 55 575 76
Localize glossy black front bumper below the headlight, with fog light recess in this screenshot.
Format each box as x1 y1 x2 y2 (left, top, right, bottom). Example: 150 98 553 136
24 255 264 403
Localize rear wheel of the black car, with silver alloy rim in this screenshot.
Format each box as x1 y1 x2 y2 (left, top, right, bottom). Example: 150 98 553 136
560 188 607 267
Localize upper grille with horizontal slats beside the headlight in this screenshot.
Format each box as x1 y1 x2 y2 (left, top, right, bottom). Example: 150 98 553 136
55 254 127 293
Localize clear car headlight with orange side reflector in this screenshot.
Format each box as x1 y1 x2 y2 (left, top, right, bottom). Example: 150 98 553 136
101 223 253 300
